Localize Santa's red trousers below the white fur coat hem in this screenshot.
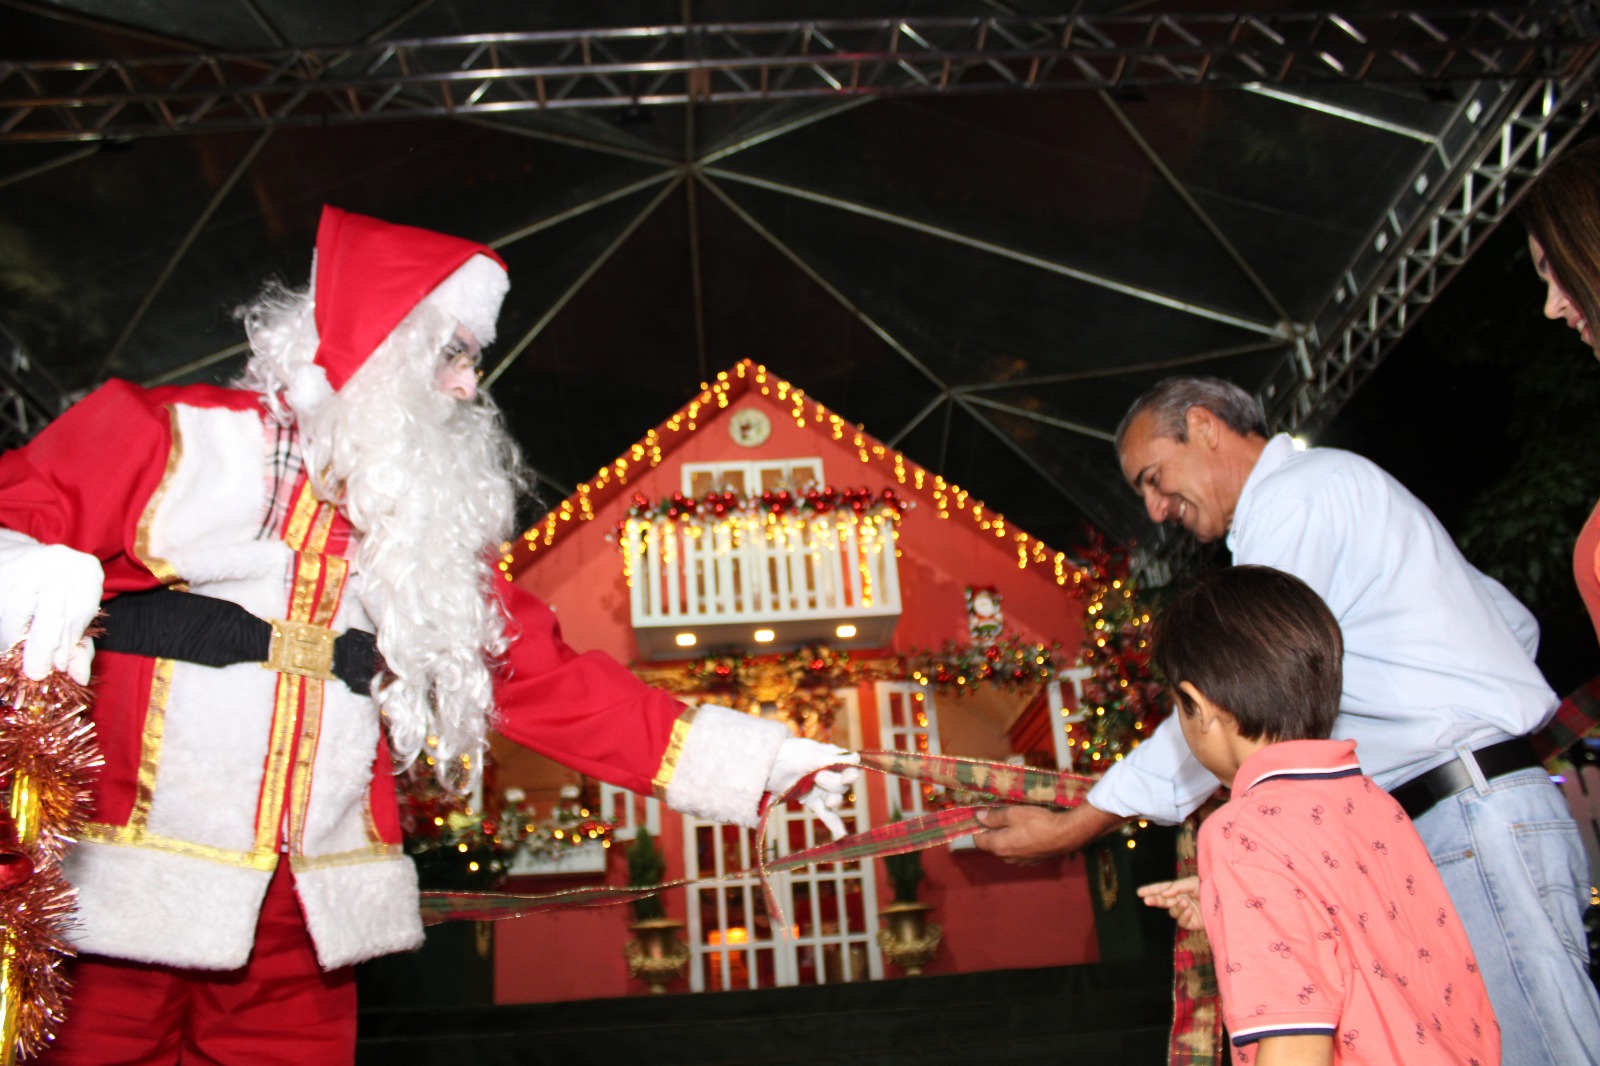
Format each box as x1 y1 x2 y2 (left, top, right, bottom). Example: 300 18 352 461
38 861 355 1066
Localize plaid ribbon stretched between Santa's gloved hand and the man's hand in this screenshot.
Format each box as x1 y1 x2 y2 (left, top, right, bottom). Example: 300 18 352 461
422 751 1094 928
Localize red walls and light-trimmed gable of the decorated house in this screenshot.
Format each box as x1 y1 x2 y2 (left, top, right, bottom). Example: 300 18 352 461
494 362 1098 999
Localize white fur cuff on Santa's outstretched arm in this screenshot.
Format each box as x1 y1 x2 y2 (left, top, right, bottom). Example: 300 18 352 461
666 706 792 828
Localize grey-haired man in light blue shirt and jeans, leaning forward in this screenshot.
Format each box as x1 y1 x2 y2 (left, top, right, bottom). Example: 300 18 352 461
978 378 1600 1064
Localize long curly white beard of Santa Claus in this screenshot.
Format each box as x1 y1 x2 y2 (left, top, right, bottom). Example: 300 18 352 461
245 286 523 789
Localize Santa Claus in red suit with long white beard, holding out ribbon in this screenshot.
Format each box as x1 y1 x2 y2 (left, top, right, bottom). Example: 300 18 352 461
0 208 854 1063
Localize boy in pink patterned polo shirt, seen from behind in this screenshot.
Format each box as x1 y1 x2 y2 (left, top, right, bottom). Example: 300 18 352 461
1139 567 1499 1066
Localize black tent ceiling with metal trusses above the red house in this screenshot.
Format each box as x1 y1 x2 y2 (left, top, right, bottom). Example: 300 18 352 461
0 0 1597 557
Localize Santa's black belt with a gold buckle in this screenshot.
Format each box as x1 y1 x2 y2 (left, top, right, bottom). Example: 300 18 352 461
94 589 382 696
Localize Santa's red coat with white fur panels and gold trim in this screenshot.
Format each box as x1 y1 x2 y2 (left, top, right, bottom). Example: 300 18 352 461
0 381 787 968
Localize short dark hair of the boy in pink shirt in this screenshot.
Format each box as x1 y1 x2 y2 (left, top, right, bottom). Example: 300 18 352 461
1155 567 1344 741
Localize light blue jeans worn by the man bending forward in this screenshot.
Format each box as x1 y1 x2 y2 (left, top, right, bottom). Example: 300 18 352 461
1416 762 1600 1066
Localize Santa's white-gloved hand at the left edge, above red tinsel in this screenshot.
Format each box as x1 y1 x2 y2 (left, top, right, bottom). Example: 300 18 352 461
0 530 106 685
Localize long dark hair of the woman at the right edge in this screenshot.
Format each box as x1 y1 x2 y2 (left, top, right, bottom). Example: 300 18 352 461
1517 138 1600 352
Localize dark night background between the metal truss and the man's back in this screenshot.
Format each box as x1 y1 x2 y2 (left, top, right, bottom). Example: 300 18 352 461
1315 221 1600 693
